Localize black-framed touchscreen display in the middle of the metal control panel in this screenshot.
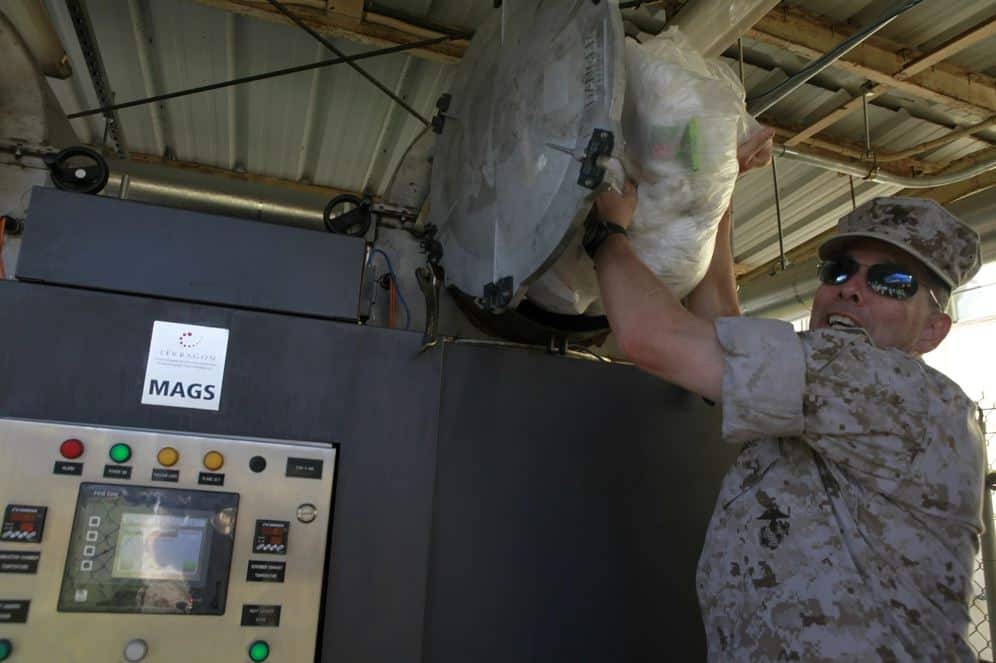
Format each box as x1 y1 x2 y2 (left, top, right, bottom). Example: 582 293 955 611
59 483 239 615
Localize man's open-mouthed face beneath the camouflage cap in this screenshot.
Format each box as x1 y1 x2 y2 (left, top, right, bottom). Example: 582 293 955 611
809 239 950 354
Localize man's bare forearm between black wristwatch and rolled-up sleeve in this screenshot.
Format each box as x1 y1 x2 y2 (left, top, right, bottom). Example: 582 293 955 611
595 235 723 400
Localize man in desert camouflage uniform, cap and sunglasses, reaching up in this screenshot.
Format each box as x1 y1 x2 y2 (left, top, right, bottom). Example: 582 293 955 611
589 190 984 663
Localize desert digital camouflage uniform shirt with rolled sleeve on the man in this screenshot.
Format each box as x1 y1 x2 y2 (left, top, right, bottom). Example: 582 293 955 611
697 318 984 663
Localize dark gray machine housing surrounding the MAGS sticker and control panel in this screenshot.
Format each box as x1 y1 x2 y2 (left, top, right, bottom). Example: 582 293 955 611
0 191 736 663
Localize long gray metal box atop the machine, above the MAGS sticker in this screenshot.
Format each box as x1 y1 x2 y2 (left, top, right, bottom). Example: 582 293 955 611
17 187 365 320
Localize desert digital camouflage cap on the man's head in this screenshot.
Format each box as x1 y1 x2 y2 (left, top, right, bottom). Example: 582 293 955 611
820 196 982 290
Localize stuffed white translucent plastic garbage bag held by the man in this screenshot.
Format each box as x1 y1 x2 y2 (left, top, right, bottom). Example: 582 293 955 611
527 28 760 315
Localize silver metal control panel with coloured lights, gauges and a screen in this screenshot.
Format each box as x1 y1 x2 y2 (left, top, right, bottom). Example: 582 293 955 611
0 419 336 663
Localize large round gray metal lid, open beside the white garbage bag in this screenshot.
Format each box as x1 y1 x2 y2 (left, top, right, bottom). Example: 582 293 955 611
428 0 625 311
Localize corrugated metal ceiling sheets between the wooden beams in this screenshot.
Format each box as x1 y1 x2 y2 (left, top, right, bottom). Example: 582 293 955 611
35 0 996 274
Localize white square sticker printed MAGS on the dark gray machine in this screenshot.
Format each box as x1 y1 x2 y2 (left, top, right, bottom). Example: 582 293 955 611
142 320 228 411
